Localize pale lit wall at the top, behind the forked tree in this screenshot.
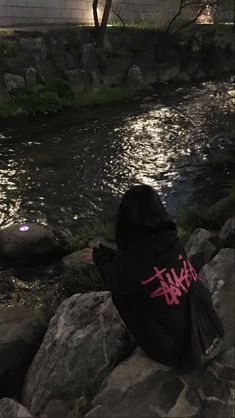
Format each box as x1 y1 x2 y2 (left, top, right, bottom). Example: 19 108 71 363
0 0 178 27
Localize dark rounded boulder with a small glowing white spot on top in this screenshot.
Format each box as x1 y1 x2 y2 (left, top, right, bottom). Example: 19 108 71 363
0 223 62 266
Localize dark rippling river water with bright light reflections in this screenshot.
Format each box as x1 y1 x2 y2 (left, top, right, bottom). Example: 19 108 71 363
0 79 235 229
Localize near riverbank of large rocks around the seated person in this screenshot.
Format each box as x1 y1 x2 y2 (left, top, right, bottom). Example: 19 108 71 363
0 214 235 418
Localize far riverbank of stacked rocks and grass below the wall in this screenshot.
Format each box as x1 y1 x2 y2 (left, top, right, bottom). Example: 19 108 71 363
0 25 234 116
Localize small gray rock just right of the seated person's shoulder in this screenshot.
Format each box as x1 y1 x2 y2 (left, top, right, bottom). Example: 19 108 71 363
185 228 216 271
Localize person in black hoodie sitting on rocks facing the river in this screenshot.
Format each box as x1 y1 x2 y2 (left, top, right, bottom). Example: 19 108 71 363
82 185 223 369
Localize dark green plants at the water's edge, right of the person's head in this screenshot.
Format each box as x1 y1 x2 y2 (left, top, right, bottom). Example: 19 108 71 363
177 184 235 240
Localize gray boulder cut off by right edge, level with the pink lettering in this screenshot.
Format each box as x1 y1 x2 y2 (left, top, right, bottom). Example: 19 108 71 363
199 248 235 348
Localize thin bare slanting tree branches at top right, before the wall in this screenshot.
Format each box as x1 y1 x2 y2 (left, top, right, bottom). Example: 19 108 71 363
166 0 218 32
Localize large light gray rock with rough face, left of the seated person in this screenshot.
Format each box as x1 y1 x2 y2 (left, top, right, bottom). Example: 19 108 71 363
23 292 133 414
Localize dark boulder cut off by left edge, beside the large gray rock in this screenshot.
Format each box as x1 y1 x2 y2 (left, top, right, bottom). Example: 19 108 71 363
0 307 45 396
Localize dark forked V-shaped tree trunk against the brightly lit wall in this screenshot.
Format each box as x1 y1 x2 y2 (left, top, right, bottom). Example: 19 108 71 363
92 0 112 48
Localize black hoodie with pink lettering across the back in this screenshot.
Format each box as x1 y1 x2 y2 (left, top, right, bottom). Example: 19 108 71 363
93 222 202 368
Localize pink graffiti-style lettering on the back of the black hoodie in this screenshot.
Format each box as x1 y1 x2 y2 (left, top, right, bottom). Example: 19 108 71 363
141 255 199 305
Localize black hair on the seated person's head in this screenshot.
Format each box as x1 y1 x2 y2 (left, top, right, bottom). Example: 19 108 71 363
116 184 169 248
